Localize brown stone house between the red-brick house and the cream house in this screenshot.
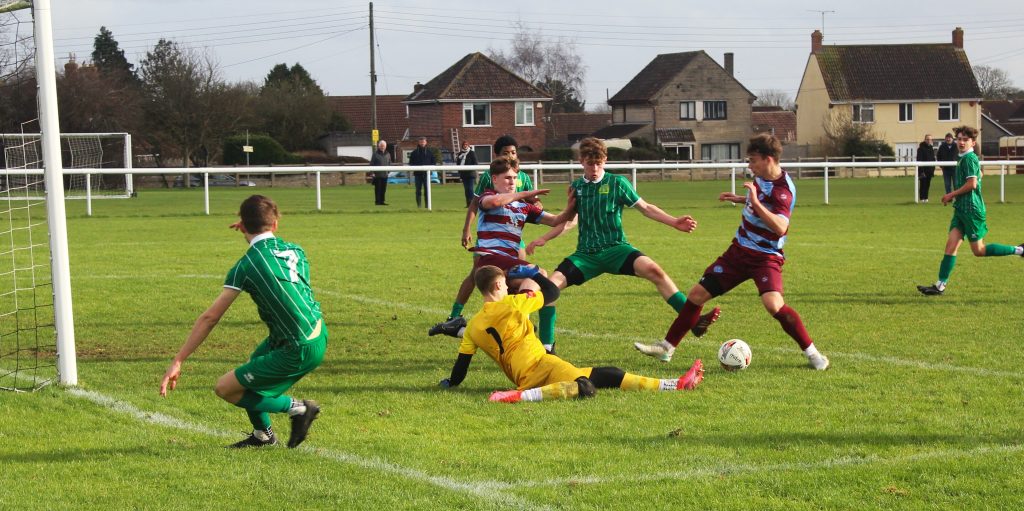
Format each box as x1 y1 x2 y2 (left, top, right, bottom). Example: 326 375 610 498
594 50 756 160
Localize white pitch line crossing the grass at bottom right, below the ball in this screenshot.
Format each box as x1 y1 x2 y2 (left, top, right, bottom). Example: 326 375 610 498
520 444 1024 486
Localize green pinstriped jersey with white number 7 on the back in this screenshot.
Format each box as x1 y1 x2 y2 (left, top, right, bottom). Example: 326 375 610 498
224 232 321 346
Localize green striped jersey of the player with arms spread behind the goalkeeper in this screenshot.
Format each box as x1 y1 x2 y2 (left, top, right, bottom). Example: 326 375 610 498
571 172 640 254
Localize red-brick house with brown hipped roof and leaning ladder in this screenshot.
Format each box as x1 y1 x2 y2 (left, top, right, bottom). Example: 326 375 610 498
401 52 552 163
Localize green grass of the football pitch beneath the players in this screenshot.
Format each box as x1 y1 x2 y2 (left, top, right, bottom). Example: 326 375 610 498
0 176 1024 510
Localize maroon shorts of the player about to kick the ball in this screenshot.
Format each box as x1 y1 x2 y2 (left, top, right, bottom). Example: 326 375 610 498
700 242 785 296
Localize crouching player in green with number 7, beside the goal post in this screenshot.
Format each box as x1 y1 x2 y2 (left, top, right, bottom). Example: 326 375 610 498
160 196 327 448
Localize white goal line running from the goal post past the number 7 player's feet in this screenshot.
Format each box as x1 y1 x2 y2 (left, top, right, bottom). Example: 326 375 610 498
68 387 550 510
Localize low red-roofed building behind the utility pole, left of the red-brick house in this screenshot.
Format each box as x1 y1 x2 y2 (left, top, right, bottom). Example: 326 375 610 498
319 94 408 160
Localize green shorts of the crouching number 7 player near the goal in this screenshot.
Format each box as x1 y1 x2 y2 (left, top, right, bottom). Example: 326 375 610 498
234 328 327 397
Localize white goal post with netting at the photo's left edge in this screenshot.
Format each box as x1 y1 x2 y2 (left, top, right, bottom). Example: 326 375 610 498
0 0 78 390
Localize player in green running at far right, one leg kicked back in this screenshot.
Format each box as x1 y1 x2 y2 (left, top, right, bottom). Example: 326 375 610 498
918 126 1024 296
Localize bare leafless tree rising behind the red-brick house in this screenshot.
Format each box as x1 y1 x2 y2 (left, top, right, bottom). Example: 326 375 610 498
487 22 587 113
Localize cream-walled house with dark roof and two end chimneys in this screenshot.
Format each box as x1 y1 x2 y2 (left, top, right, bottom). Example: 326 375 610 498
797 27 981 159
